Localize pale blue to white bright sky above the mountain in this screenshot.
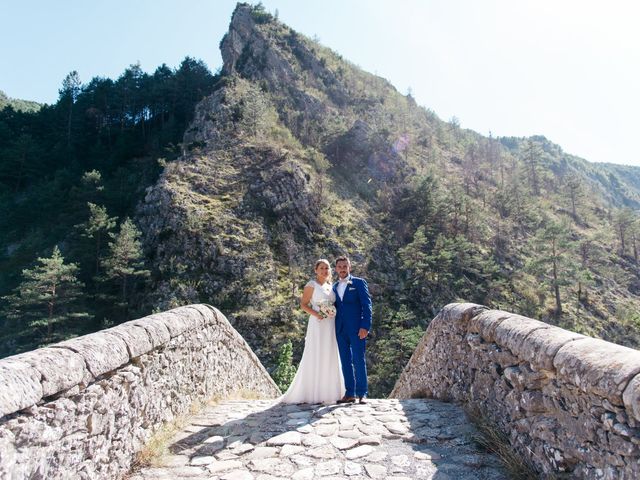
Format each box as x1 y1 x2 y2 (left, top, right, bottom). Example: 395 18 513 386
0 0 640 165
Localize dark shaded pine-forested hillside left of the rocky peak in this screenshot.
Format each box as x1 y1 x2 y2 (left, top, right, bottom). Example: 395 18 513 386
0 58 217 355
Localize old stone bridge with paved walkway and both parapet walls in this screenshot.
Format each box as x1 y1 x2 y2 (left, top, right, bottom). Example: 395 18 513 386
0 304 640 480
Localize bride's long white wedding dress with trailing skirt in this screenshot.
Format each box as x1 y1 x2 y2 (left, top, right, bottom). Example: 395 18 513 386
279 280 345 403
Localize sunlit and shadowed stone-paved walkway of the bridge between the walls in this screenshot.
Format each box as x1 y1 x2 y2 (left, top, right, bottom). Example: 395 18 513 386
129 399 508 480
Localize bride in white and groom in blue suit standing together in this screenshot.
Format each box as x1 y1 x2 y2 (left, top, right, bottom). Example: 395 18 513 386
280 256 371 403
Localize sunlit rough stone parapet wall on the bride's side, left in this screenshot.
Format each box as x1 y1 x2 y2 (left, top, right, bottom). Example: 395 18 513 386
0 305 280 479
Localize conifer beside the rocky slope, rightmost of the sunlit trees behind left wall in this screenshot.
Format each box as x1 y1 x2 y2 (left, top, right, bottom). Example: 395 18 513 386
102 218 150 315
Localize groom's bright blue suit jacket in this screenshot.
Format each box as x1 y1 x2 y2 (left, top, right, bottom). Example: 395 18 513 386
333 275 371 335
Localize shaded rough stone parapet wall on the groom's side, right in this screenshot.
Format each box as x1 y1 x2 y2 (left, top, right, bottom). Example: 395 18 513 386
391 304 640 480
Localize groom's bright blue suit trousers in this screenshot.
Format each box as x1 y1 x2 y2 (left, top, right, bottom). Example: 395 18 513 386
336 331 368 397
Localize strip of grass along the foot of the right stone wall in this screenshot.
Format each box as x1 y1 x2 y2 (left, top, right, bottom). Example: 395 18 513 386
465 404 557 480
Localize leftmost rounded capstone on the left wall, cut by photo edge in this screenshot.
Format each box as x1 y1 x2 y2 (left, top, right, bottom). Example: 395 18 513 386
0 358 42 418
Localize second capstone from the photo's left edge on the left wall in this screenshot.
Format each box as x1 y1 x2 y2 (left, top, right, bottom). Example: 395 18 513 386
10 348 86 397
